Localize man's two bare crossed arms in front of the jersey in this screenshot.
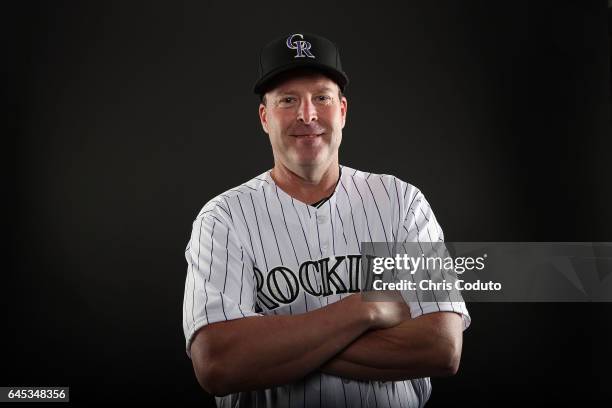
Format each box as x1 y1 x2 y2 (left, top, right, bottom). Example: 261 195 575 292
191 294 463 396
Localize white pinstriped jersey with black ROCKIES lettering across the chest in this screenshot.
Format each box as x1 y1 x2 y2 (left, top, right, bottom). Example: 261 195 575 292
183 166 470 408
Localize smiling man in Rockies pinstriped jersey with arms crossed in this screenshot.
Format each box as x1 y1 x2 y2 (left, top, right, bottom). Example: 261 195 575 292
183 34 469 407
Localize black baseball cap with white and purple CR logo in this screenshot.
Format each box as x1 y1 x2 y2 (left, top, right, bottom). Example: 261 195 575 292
253 33 348 95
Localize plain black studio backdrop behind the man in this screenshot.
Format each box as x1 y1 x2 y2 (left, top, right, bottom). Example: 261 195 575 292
5 0 612 406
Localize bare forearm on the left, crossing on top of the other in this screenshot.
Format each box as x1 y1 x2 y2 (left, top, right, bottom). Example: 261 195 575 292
191 295 402 395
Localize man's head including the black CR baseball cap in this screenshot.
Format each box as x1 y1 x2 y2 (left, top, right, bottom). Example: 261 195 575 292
254 34 348 174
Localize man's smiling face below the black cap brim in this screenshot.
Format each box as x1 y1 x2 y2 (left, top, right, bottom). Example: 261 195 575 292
259 74 347 172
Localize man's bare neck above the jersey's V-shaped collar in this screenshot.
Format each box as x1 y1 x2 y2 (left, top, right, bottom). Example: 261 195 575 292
270 161 340 204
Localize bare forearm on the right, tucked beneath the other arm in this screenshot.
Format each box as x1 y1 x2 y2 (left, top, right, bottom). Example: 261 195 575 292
321 312 462 381
